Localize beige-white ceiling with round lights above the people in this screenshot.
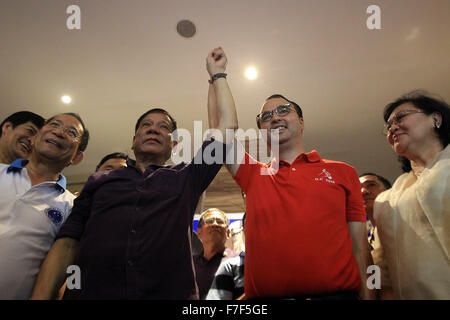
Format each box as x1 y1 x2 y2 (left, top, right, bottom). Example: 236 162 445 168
0 0 450 182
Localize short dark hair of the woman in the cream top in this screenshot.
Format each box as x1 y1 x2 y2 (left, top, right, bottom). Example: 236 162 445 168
383 90 450 172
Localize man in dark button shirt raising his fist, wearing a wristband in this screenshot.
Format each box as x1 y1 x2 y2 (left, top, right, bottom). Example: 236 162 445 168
32 48 238 299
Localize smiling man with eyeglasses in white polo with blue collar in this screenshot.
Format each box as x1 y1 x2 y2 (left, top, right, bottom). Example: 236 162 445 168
0 113 89 300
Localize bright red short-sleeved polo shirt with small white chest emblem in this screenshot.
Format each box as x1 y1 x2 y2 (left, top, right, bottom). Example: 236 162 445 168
234 151 365 298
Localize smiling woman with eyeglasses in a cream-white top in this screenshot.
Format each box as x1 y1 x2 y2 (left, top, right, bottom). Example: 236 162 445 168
373 91 450 299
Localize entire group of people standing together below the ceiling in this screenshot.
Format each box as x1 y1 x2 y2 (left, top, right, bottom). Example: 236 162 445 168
0 47 450 300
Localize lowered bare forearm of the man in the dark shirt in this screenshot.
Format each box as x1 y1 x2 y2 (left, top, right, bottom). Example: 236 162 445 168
30 238 79 300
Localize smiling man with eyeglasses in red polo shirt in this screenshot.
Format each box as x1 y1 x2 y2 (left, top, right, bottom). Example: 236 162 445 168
208 83 371 299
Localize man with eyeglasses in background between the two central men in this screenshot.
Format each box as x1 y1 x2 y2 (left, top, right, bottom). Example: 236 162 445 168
193 208 234 300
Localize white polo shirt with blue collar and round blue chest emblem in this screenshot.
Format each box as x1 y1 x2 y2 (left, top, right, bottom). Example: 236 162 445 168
0 159 75 300
